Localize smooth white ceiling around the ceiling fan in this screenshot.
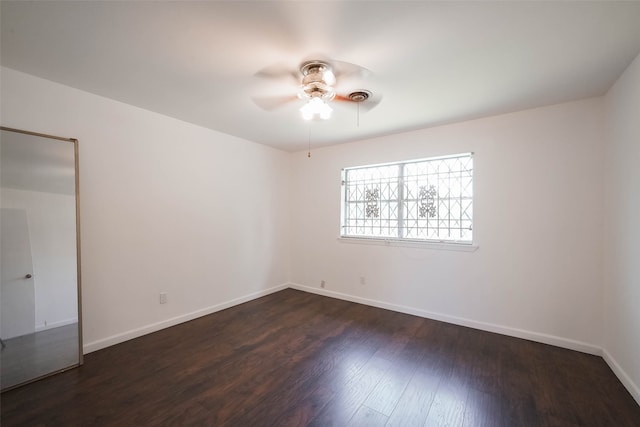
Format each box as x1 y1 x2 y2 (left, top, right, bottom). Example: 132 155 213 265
1 0 640 151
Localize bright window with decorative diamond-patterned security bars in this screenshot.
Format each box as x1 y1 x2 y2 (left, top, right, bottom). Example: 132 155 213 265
340 153 473 244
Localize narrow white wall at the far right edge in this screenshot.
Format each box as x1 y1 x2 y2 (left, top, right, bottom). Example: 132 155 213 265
604 51 640 403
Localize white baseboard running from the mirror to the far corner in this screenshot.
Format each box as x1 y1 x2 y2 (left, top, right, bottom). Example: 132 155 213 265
82 284 289 354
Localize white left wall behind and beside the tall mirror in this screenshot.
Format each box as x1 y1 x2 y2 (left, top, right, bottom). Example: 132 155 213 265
1 68 290 352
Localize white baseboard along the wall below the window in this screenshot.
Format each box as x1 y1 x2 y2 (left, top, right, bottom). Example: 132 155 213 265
289 283 602 356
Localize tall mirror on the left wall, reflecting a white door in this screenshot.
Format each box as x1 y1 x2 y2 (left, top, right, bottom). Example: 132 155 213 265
0 127 82 391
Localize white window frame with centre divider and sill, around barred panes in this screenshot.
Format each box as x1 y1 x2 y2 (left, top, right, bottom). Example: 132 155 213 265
339 152 477 250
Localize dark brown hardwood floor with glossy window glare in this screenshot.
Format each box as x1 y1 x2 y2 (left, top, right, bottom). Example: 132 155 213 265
0 289 640 427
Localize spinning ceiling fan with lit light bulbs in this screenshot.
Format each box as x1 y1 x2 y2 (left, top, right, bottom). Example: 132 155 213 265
253 59 382 120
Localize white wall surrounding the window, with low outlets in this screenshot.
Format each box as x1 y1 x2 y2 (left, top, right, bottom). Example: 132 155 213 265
291 98 603 353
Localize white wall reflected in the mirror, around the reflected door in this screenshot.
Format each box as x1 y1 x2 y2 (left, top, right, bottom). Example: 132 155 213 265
0 188 78 331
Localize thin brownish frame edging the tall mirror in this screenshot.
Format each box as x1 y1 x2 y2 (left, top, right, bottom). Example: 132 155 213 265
0 126 84 393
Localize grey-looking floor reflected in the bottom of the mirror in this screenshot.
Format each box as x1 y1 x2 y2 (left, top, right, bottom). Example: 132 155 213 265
0 323 79 389
